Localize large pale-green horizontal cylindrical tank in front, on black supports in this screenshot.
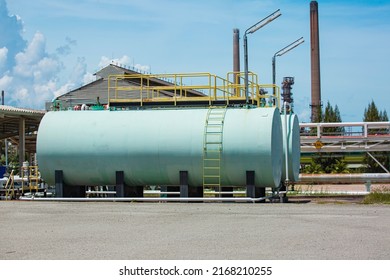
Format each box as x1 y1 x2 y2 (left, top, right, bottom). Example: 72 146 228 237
37 108 283 187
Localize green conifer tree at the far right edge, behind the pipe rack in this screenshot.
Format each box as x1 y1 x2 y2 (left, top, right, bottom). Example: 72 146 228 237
363 100 390 173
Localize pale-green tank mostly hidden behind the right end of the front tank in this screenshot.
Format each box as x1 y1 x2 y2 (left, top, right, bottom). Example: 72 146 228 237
280 114 301 182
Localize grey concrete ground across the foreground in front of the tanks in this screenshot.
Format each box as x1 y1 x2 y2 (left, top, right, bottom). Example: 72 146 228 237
0 200 390 260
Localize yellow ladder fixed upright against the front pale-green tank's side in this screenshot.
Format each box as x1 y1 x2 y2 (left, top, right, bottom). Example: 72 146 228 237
203 107 226 195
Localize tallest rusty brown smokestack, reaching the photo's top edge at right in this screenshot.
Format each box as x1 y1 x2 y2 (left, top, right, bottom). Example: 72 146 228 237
310 1 321 122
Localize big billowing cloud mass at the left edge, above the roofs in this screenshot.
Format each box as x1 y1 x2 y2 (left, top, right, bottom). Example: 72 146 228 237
0 0 92 108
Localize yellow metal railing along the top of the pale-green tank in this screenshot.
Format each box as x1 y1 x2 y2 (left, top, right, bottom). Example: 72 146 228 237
108 73 280 106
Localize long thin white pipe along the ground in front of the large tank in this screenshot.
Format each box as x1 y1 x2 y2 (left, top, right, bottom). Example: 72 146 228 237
19 196 274 203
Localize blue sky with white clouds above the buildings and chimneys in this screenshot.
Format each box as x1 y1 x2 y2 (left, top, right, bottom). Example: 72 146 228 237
0 0 390 121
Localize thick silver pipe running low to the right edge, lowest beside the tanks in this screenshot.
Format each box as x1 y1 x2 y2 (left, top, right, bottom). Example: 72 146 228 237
298 173 390 184
